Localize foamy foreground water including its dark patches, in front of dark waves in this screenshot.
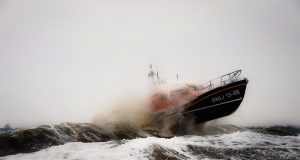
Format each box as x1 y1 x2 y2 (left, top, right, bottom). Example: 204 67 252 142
0 131 300 160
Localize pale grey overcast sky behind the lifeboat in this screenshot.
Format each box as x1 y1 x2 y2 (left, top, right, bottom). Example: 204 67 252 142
0 0 300 127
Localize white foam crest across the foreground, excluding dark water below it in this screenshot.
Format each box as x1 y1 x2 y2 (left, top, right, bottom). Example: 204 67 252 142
0 131 300 160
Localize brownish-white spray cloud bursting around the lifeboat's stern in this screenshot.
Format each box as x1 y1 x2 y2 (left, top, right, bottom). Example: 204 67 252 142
92 88 202 136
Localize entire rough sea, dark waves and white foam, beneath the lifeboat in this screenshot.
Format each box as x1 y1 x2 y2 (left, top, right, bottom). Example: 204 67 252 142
0 123 300 160
